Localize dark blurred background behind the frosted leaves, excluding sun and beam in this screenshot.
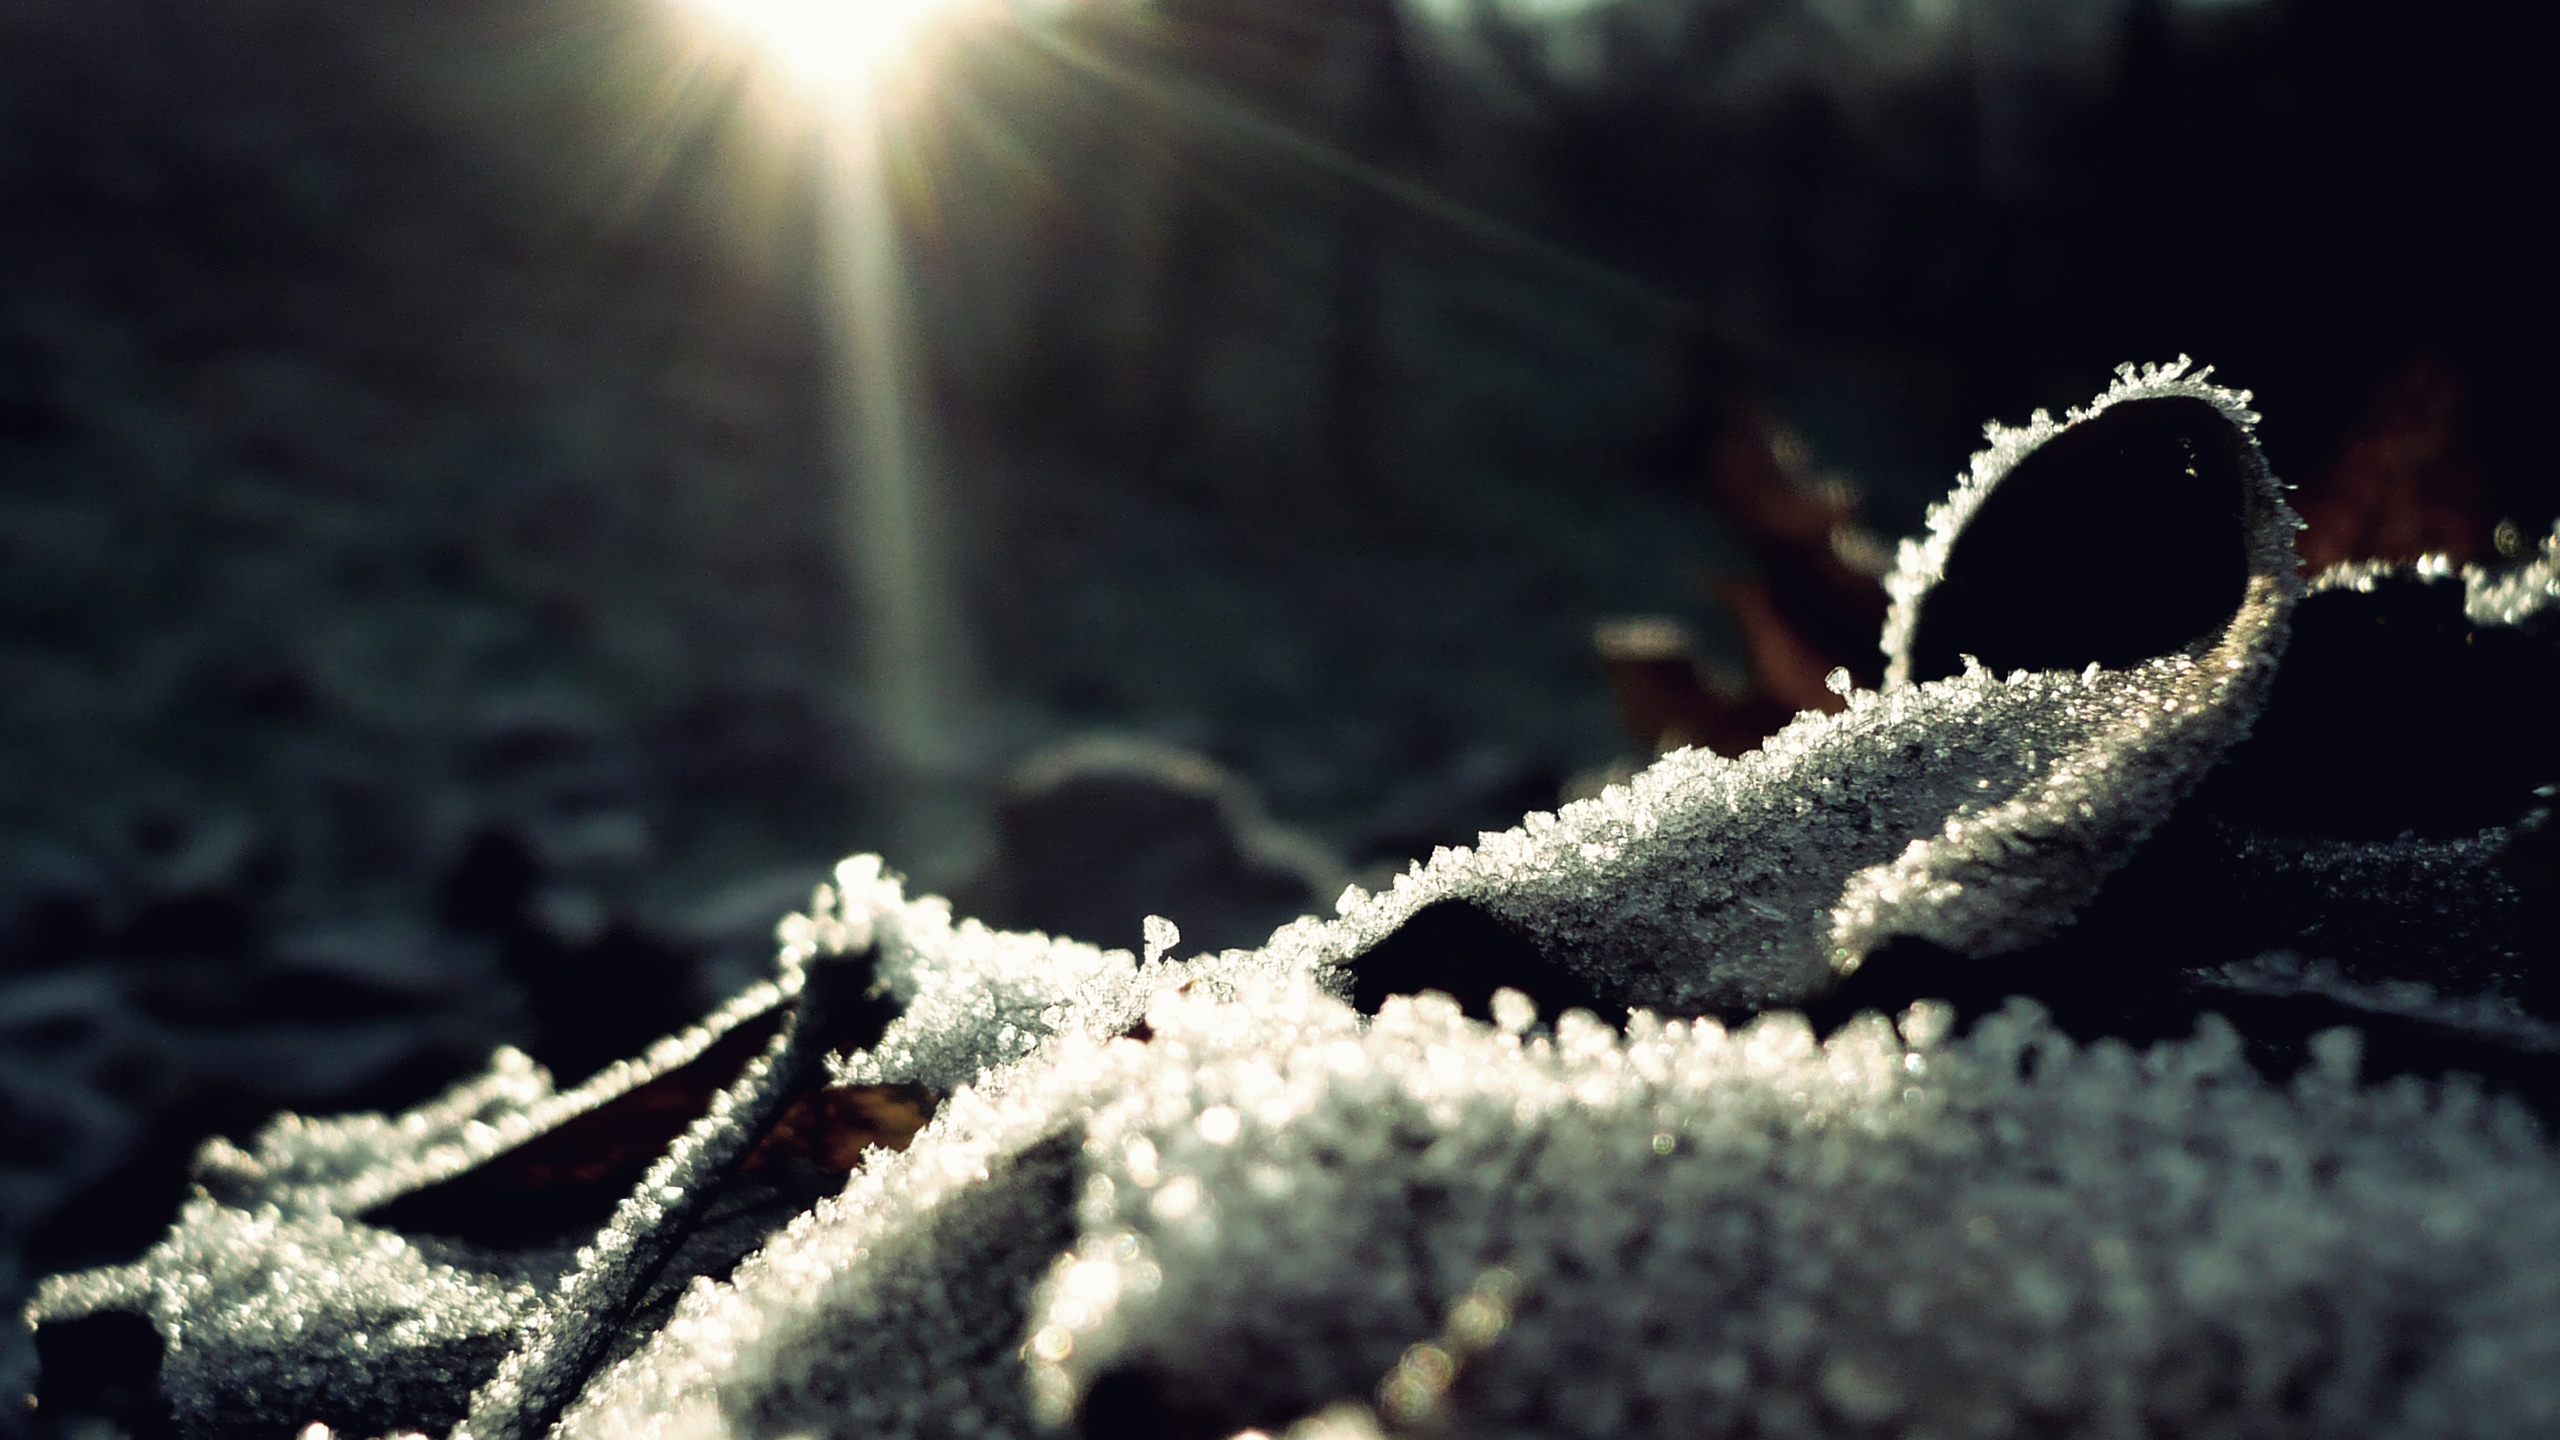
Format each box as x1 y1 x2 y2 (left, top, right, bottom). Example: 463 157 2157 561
0 0 2560 1386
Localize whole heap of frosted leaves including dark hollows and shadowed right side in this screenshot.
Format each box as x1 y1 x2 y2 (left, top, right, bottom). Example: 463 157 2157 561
36 364 2560 1440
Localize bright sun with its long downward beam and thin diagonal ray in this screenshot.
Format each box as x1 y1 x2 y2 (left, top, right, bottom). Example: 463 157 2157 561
619 0 1751 869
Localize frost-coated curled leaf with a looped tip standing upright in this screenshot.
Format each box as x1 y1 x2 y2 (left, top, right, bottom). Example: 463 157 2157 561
1275 359 2301 1015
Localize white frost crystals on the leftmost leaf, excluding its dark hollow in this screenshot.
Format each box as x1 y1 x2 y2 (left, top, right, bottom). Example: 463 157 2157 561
33 966 799 1432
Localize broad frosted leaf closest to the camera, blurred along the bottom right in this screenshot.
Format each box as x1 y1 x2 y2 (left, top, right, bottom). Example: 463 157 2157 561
563 953 2560 1437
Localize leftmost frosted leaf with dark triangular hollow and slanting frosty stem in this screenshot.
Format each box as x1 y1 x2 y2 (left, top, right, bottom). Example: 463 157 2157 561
36 948 890 1435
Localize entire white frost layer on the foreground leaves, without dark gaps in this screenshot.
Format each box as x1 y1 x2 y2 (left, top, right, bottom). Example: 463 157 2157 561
33 364 2560 1440
